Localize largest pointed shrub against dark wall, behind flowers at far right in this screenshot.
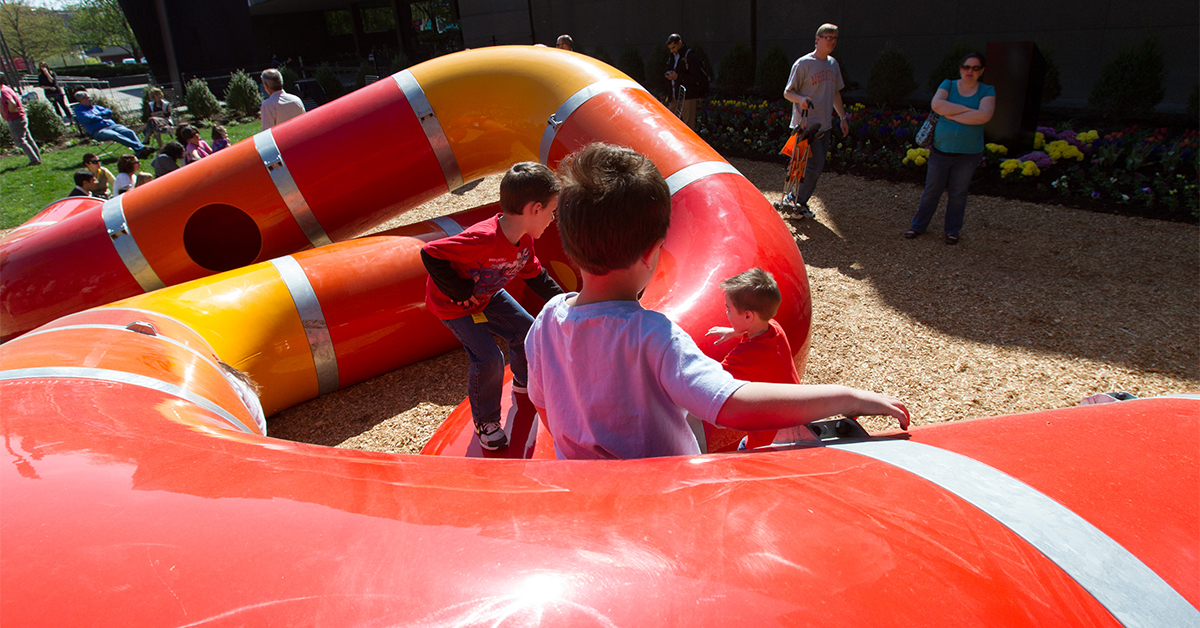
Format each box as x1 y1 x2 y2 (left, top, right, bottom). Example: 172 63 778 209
1087 35 1166 118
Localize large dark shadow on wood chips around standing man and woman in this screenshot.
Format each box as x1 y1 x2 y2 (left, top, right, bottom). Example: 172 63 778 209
737 161 1200 379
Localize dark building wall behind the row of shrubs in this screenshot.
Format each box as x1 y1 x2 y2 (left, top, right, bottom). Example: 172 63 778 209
458 0 1200 112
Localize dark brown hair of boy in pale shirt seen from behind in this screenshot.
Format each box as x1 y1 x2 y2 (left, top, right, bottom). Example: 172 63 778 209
558 143 671 275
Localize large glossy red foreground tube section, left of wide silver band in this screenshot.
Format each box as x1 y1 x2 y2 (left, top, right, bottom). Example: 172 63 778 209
7 391 1180 626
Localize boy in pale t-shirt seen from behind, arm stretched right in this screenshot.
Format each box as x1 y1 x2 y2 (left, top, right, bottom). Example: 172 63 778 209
526 144 908 459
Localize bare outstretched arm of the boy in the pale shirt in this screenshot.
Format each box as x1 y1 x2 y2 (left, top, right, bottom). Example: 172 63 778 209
715 382 908 432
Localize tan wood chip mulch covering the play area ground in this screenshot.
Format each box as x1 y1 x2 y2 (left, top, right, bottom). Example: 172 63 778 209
260 160 1200 454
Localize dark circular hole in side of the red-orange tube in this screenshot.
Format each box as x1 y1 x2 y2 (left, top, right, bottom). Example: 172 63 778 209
184 203 263 273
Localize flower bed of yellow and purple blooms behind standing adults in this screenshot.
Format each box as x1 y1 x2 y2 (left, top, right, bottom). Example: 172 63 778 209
696 100 1200 222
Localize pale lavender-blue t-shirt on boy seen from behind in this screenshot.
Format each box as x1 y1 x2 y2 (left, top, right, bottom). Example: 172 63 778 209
526 293 745 460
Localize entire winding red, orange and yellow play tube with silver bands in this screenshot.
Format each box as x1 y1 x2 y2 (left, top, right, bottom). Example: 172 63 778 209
0 47 1200 627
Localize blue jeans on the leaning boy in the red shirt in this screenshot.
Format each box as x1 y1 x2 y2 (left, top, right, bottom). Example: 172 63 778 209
442 291 533 424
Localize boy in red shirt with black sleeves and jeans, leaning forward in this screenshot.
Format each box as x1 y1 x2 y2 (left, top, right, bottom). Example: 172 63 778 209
421 161 563 451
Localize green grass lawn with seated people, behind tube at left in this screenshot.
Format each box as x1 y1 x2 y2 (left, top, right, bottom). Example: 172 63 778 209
0 120 262 229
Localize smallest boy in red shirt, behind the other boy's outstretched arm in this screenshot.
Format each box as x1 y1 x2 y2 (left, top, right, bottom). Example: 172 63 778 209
706 268 800 451
